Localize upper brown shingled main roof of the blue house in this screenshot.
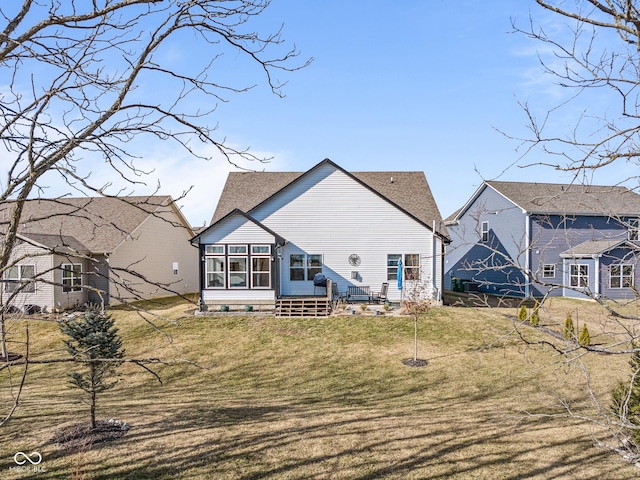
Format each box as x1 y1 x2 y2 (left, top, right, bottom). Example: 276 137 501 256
486 181 640 216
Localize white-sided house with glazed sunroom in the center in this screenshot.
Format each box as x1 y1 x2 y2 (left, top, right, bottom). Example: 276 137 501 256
192 159 448 308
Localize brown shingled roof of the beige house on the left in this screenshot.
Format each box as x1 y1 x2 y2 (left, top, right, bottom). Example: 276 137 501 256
0 195 188 254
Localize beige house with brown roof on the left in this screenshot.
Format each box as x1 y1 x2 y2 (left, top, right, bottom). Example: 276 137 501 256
0 196 198 310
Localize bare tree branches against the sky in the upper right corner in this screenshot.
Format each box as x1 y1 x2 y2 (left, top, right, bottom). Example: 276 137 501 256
514 0 640 178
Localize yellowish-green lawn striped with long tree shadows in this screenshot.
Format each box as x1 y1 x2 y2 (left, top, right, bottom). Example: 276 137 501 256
0 300 640 480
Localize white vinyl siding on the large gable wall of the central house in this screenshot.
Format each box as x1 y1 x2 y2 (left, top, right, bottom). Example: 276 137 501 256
251 165 433 301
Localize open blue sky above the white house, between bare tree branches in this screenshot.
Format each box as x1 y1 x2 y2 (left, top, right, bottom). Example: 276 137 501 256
11 0 632 226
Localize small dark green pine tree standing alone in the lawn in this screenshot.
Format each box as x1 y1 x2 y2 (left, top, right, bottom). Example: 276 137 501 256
60 305 124 428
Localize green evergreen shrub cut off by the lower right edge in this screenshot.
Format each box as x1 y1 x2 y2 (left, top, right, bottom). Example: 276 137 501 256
611 345 640 447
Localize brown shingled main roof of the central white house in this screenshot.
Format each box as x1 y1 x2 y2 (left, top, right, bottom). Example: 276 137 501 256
211 160 448 236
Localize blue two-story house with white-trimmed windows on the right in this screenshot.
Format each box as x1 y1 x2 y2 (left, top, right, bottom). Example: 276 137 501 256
445 181 640 298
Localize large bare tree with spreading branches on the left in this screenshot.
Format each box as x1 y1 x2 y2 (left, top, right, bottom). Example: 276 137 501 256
0 0 308 422
